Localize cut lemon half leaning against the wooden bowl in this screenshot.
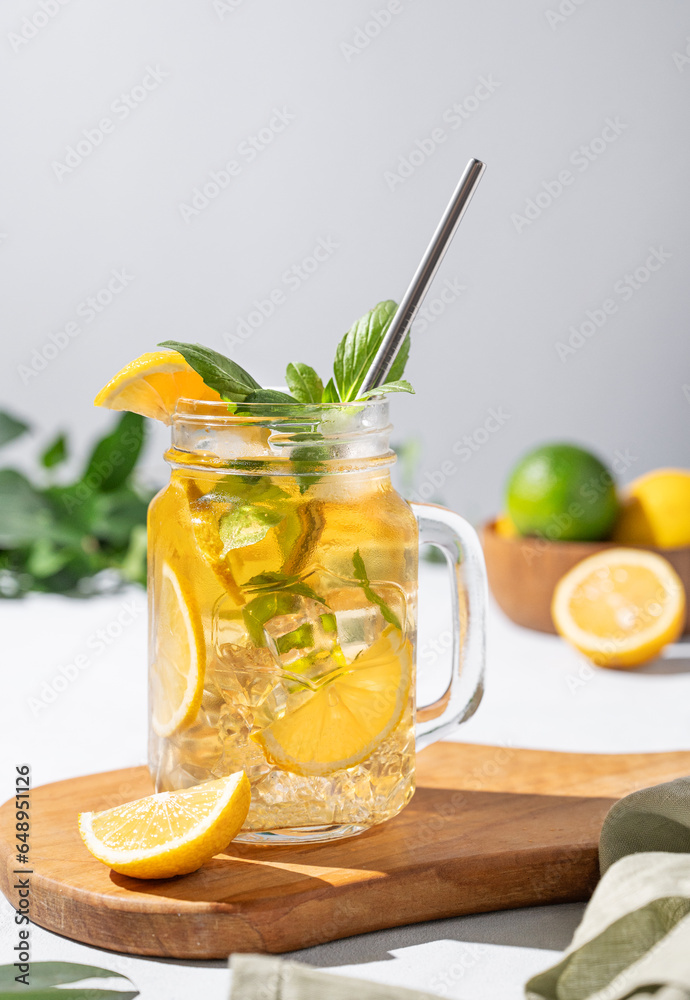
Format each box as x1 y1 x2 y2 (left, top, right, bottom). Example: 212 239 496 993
551 548 685 668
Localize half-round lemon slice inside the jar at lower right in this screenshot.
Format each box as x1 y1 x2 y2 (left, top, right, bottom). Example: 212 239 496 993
252 625 412 774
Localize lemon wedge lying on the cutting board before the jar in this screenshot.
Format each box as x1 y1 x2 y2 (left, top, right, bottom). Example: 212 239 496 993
79 771 251 878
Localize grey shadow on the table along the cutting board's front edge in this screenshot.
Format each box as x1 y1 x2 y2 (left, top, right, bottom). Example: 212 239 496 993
281 903 585 968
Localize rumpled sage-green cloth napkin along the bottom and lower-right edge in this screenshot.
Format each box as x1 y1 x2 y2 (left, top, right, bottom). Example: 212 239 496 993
230 778 690 1000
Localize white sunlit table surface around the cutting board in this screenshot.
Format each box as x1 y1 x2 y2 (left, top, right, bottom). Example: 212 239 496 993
0 565 690 1000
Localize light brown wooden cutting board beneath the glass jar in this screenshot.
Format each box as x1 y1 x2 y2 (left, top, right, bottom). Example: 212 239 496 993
0 743 690 959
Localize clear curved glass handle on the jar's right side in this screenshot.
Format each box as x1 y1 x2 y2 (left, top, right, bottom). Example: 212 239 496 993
410 503 488 750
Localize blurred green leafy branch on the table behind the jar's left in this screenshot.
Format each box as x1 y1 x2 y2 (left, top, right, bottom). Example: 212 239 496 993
0 412 153 597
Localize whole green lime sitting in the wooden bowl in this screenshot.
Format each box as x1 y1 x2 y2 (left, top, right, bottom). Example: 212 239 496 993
506 444 618 542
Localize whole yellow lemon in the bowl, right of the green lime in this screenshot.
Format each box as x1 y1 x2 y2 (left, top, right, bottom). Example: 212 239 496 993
613 469 690 549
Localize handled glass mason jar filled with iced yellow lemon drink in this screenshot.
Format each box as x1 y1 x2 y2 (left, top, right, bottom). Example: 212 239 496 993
149 397 486 843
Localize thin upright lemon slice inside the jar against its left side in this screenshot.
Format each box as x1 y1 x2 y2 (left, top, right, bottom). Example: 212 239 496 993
151 562 206 736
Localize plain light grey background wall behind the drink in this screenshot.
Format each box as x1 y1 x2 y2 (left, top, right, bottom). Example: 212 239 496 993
0 0 690 520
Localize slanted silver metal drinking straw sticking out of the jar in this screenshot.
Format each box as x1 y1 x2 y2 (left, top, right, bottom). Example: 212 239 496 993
360 160 486 392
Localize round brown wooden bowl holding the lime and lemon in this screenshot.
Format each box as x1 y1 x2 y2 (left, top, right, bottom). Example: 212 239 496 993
481 521 690 635
